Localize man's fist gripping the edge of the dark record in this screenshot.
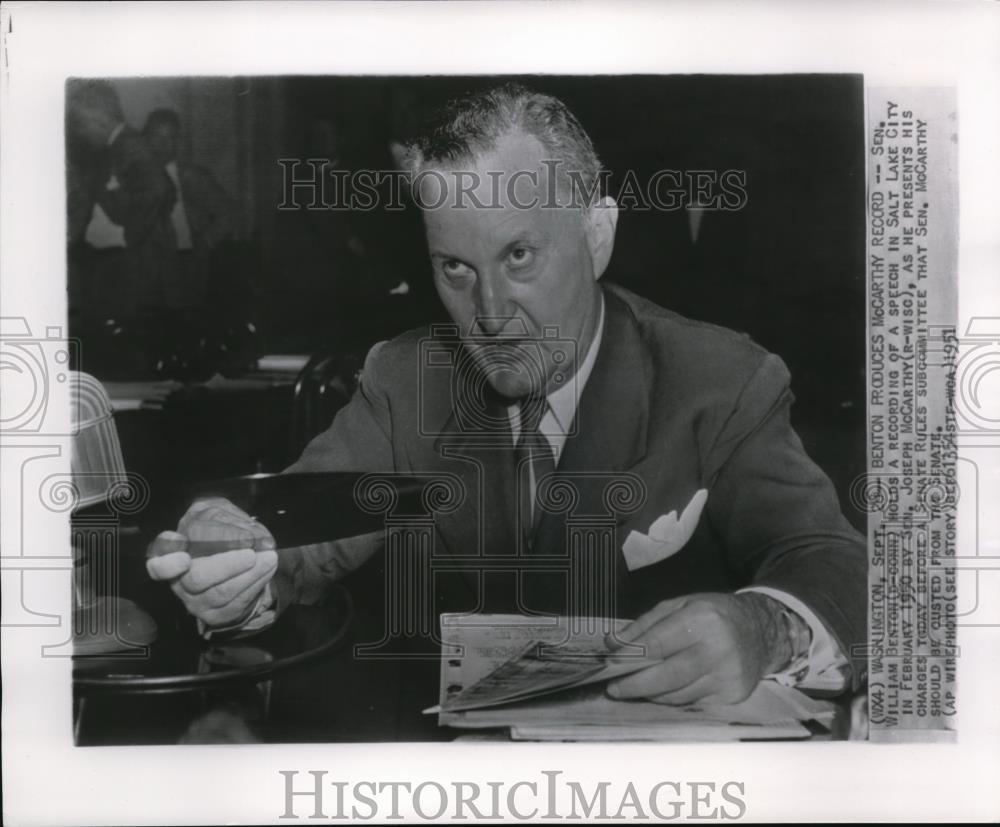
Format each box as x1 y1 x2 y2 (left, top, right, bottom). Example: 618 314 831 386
146 498 278 626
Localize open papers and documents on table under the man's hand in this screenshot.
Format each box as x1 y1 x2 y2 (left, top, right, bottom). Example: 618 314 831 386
428 614 834 741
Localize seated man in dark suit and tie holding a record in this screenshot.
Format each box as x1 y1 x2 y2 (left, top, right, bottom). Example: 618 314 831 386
148 86 866 704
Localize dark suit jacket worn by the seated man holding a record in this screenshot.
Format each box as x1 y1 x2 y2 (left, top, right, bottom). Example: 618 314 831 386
275 286 867 686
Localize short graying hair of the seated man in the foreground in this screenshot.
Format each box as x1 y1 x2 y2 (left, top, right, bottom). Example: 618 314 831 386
402 83 601 209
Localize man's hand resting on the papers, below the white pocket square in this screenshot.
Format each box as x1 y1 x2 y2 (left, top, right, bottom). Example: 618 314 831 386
608 592 791 704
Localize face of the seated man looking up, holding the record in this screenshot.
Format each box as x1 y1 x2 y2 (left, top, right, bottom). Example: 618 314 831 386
420 133 614 399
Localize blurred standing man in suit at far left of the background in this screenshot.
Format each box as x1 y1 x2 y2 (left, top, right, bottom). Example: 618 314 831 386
66 78 181 379
